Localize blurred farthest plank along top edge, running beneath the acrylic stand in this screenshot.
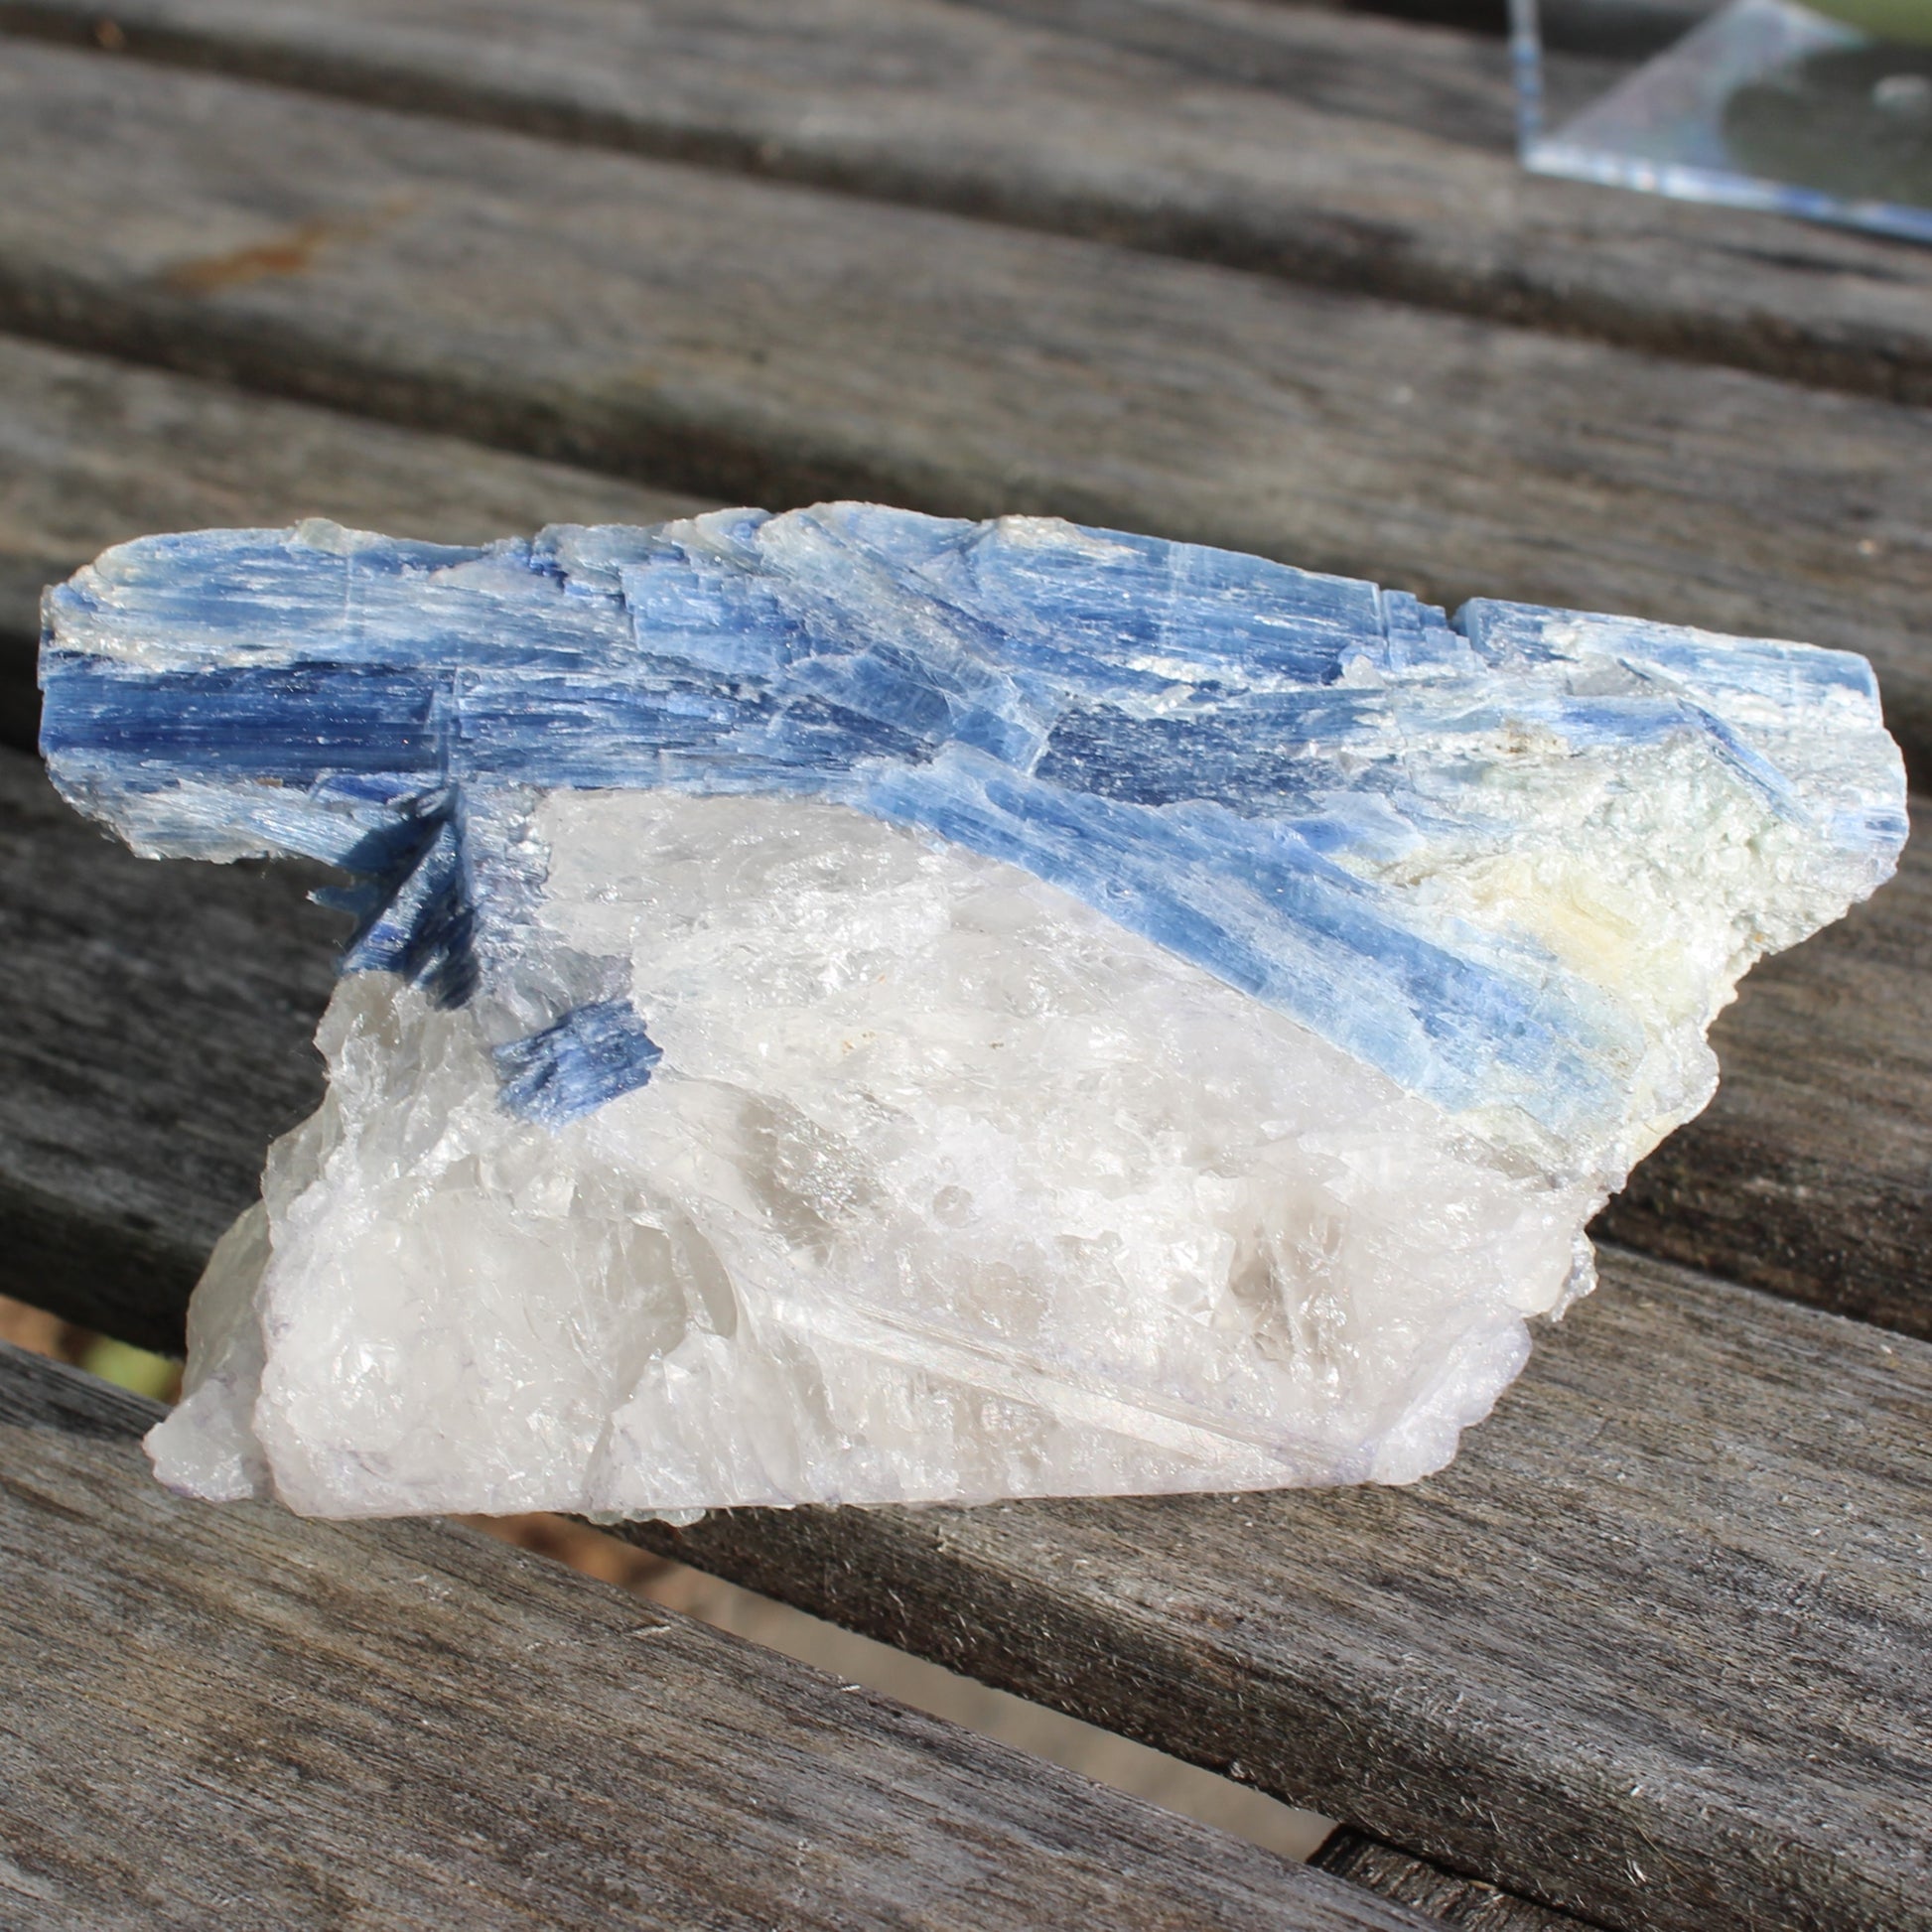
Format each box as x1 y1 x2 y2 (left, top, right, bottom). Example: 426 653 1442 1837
0 0 1932 402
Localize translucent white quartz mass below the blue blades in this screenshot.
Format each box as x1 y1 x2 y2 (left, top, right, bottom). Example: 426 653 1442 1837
151 792 1595 1515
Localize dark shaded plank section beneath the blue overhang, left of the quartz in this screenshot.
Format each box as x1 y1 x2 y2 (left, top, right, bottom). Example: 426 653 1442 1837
0 752 345 1354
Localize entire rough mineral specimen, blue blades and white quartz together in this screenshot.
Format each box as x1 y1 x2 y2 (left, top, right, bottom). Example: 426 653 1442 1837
43 504 1905 1515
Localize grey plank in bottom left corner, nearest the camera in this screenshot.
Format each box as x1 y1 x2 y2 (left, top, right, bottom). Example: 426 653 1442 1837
0 1346 1424 1932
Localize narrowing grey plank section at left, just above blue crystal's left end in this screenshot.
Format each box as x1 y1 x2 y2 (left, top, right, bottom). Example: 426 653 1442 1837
0 337 698 748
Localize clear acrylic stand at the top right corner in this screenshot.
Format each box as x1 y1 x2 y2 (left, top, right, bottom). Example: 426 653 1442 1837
1511 0 1932 241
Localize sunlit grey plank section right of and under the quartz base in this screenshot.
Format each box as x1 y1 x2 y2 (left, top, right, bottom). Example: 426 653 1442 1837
631 1256 1932 1932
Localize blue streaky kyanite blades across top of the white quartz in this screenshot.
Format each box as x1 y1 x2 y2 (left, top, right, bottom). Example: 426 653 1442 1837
41 504 1903 1138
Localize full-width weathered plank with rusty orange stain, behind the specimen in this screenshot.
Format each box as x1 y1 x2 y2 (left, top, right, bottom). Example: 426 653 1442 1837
0 43 1932 769
